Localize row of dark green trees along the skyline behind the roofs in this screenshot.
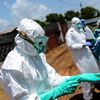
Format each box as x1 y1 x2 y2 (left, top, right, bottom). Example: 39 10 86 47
36 6 100 23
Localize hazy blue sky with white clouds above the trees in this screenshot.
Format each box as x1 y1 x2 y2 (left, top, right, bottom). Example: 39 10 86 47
0 0 100 32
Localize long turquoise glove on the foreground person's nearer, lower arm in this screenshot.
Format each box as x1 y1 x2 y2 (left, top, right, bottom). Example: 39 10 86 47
40 79 79 100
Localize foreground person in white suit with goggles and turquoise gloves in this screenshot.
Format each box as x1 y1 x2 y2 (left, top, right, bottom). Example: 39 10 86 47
0 18 100 100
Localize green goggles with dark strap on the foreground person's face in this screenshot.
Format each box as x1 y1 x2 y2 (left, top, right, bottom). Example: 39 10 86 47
19 32 48 54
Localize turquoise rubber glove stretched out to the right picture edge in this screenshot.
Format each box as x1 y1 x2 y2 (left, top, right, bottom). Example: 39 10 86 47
70 73 100 83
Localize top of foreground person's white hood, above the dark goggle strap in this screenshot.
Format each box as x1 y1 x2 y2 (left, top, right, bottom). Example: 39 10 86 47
17 18 45 40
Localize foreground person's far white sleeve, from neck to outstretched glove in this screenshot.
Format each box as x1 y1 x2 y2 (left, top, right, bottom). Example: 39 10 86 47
40 53 70 87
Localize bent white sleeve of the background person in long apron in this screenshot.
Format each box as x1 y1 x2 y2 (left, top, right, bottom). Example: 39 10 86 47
65 33 83 50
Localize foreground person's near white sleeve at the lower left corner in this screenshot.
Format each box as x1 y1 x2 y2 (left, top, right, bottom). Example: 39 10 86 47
2 69 40 100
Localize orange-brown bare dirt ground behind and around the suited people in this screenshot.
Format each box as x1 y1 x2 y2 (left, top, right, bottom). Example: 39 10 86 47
0 44 100 100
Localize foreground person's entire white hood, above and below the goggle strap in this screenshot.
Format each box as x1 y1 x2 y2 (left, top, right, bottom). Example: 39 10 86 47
15 18 45 56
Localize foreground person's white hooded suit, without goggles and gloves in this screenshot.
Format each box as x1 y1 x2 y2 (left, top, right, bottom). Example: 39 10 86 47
0 19 69 100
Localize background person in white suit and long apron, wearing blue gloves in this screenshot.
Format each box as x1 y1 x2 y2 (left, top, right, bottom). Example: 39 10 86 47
65 17 99 100
